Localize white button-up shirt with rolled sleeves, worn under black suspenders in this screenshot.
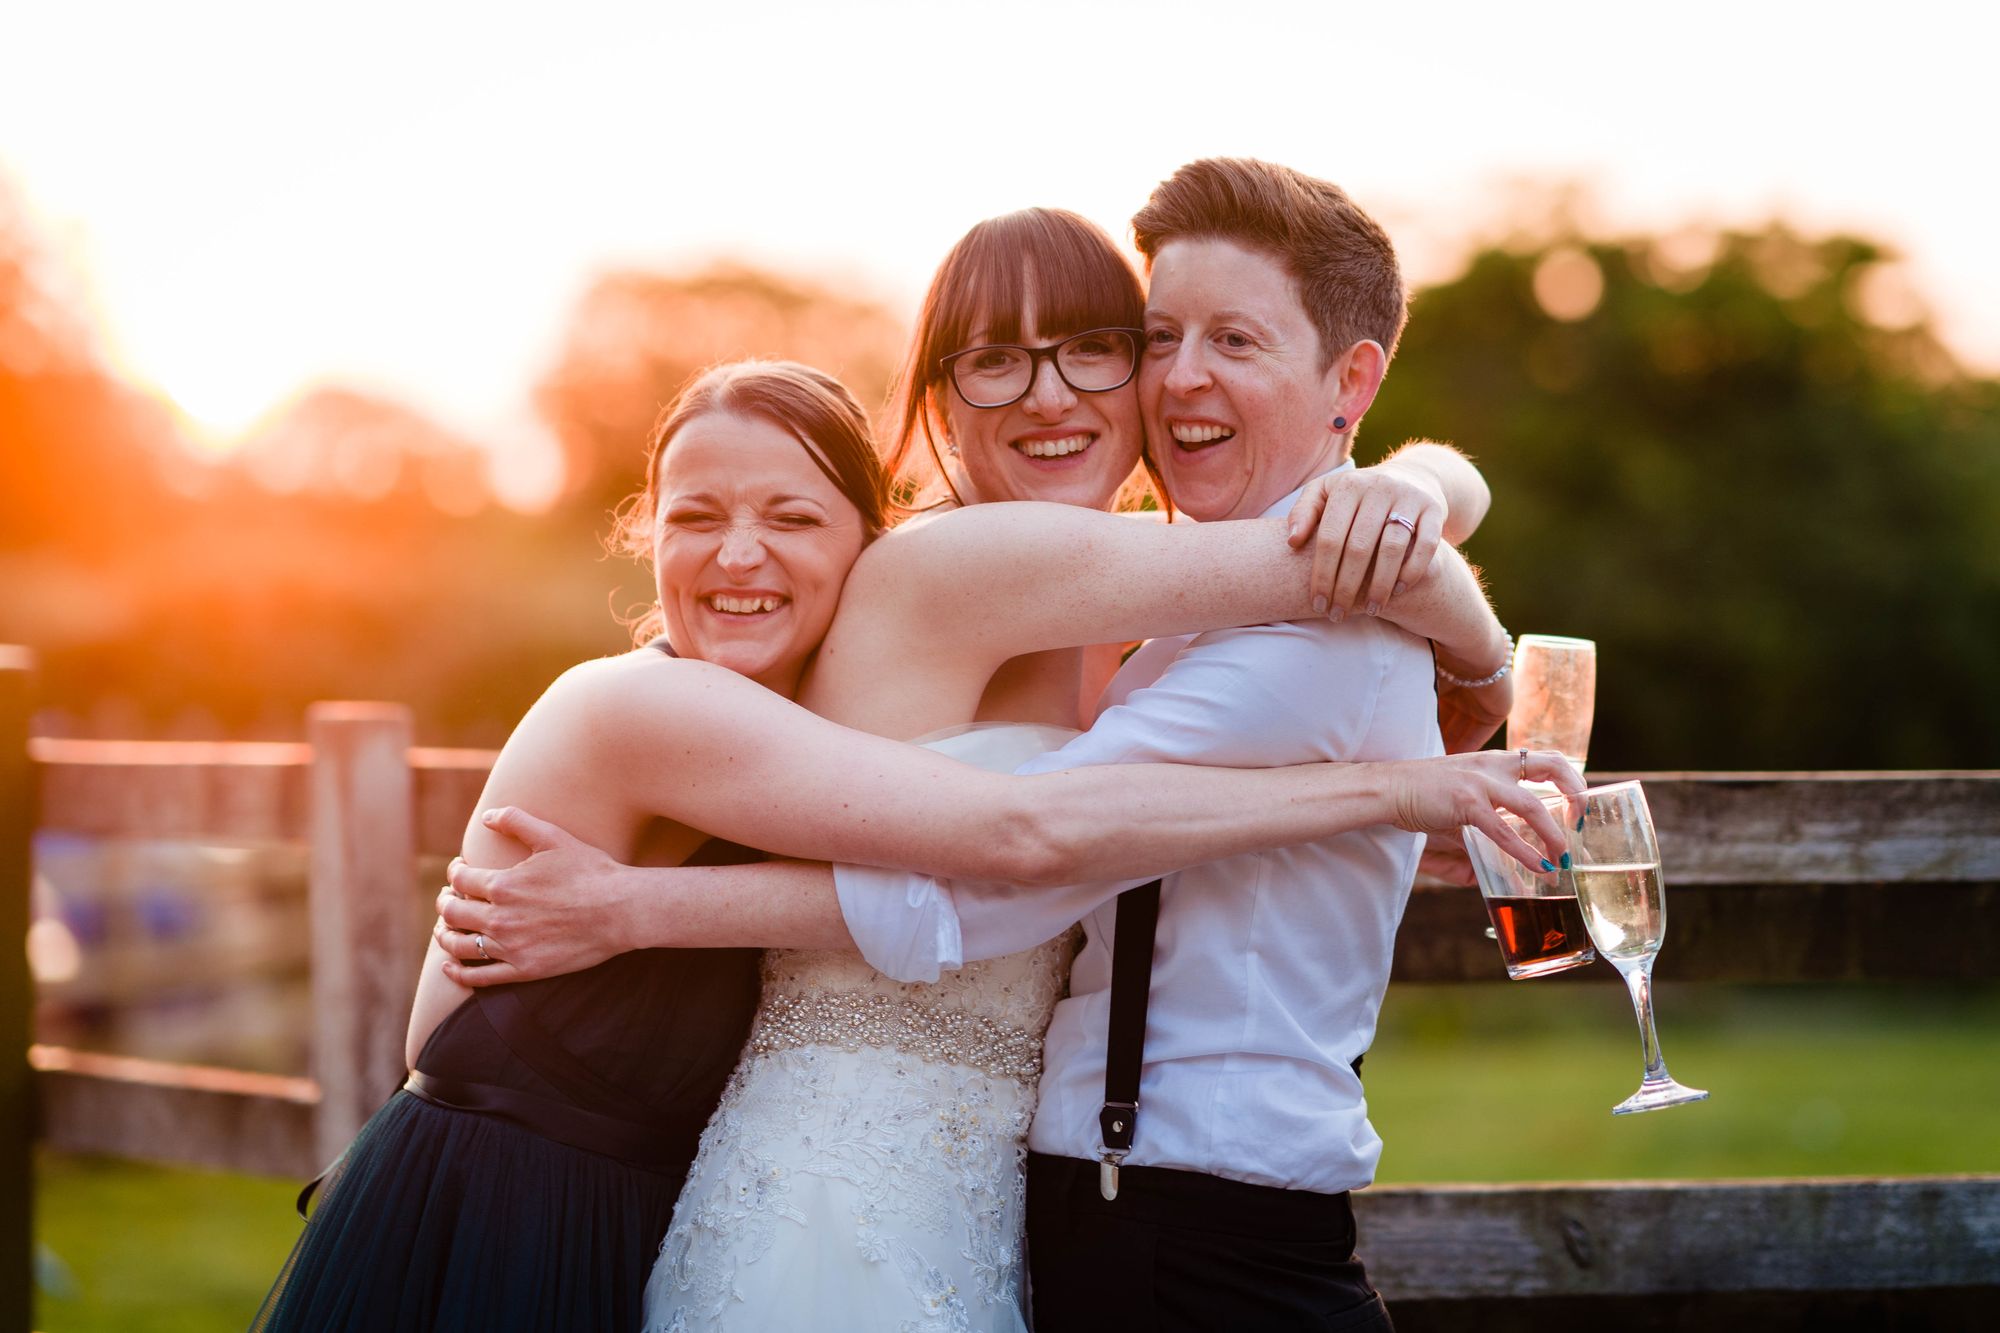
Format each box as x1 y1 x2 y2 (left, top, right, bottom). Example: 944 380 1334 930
836 472 1444 1193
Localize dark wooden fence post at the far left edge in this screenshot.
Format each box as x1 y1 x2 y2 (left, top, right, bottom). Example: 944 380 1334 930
0 646 34 1333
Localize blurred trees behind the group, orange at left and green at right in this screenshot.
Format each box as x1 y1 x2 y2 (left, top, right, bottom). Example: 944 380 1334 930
0 174 2000 769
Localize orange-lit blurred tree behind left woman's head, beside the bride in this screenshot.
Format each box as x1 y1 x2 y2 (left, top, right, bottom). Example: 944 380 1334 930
536 266 904 512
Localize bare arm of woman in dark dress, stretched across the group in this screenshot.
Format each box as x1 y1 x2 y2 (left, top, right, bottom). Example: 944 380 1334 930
468 654 1554 885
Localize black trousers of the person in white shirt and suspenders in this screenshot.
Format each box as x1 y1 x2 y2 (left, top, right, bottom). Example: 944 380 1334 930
1028 1153 1394 1333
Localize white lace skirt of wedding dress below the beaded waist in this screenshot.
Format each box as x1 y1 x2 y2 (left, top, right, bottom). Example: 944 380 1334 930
646 1020 1034 1333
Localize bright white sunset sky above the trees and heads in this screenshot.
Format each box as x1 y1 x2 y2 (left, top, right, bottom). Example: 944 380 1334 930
0 0 2000 498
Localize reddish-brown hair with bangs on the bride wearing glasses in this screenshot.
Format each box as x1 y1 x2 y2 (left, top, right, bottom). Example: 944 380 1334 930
888 208 1146 508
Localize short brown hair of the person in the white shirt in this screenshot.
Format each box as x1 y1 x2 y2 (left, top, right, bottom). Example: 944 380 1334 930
1132 158 1410 366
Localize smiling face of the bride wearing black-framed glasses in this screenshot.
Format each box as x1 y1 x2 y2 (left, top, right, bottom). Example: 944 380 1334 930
932 302 1144 508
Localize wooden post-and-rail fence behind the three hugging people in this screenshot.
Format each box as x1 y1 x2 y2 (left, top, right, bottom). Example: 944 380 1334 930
0 650 2000 1331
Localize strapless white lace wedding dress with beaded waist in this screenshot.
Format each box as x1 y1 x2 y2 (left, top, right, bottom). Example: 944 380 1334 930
646 725 1076 1333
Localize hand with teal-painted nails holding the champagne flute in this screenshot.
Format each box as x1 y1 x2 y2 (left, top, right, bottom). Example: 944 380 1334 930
1384 751 1584 873
